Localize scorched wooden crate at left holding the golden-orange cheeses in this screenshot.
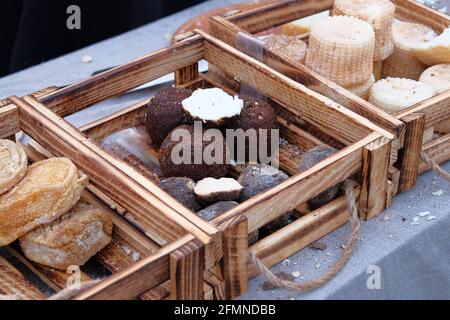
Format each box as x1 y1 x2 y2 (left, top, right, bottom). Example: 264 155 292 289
0 105 213 300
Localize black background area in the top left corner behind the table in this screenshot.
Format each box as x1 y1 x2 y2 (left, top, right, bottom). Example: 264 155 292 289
0 0 205 76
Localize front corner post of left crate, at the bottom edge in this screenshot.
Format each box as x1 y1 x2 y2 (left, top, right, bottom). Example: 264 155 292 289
170 240 205 300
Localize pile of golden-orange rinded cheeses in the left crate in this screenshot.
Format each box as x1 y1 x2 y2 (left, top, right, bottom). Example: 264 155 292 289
0 140 112 270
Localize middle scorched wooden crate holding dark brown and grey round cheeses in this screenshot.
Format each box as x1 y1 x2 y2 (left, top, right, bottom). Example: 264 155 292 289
9 31 395 298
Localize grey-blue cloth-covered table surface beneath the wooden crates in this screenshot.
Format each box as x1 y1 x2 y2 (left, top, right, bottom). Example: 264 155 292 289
0 0 450 299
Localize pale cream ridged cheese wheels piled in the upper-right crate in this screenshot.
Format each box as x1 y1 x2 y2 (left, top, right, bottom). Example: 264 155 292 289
283 0 450 161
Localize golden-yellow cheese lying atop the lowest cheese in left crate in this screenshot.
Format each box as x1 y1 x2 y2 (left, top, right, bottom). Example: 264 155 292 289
0 158 88 246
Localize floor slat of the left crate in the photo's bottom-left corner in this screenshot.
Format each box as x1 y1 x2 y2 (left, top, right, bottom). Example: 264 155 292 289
0 256 46 300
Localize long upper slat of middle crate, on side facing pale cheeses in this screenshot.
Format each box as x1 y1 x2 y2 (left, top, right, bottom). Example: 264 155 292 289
198 31 394 144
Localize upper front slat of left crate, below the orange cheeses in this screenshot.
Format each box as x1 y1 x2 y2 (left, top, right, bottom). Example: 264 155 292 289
75 235 194 300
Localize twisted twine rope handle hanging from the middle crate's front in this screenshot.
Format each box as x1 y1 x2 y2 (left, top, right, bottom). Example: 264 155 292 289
248 180 360 291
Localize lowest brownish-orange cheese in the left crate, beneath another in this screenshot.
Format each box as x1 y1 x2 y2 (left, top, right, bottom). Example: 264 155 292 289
20 201 113 270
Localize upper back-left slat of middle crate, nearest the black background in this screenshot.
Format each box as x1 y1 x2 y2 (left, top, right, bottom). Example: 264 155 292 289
42 36 203 116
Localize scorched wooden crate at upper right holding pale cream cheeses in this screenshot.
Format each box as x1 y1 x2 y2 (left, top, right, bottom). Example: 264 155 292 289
210 0 450 191
